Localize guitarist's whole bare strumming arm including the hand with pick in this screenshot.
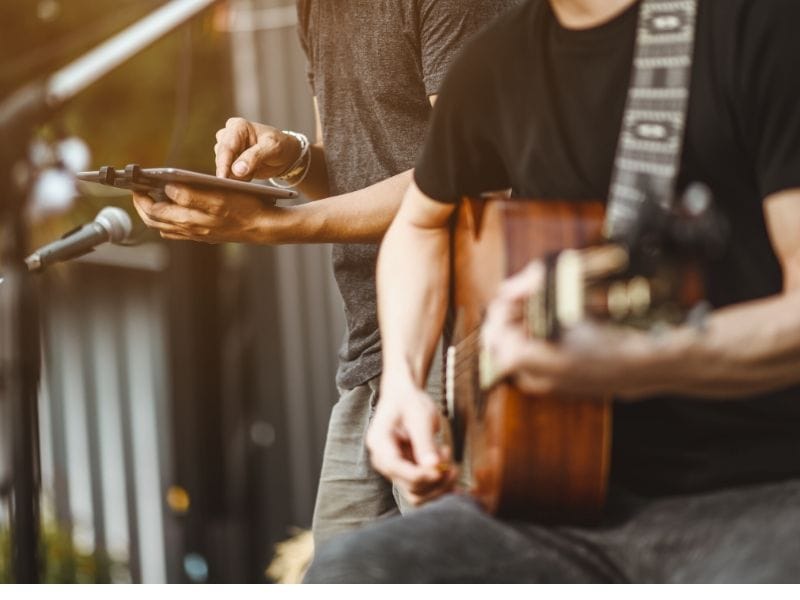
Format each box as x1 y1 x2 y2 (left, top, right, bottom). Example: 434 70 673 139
367 184 456 504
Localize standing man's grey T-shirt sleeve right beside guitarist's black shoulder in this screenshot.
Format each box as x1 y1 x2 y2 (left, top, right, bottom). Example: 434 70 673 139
419 0 516 96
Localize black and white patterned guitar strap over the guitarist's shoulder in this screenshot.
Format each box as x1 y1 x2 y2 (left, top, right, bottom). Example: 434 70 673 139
605 0 697 238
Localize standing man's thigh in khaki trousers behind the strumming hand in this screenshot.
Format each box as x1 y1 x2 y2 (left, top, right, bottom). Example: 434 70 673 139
312 380 397 546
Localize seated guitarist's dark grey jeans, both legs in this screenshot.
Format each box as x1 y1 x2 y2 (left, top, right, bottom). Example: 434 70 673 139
306 480 800 583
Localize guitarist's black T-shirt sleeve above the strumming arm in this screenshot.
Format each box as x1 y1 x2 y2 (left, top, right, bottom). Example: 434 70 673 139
414 28 509 203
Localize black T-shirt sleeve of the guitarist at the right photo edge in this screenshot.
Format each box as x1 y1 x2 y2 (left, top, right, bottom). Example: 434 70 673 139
740 0 800 198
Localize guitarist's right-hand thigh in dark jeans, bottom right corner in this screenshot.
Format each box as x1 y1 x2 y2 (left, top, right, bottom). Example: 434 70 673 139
590 480 800 583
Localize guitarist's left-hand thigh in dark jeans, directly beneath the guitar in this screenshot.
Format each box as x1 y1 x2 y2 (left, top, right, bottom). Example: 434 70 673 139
306 495 609 583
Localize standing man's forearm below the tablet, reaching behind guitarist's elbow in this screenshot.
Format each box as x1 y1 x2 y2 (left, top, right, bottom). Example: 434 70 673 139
259 171 412 244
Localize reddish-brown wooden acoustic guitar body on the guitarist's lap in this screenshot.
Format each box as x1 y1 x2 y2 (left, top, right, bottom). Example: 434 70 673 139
448 199 611 522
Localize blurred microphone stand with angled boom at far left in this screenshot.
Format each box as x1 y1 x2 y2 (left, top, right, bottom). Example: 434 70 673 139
0 0 218 583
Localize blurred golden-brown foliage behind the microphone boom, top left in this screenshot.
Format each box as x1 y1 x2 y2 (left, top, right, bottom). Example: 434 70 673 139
0 0 233 241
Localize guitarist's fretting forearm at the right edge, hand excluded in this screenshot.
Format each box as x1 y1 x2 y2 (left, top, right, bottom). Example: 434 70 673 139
651 290 800 399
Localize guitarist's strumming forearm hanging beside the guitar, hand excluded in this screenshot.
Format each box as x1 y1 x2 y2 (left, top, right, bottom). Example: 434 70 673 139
378 186 450 388
